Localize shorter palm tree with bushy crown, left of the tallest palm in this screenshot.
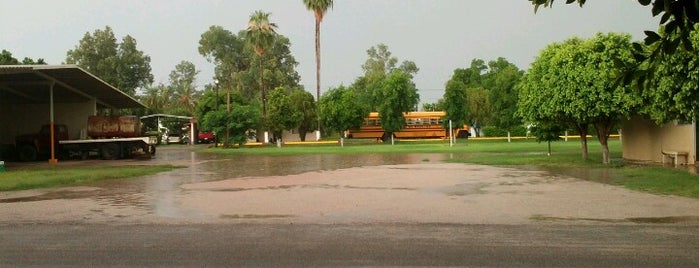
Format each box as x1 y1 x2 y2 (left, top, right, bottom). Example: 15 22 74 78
245 10 277 134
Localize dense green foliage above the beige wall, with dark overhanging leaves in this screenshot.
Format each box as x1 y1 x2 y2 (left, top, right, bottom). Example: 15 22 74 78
530 0 699 122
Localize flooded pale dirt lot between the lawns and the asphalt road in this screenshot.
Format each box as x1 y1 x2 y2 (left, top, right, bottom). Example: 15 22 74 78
0 146 699 225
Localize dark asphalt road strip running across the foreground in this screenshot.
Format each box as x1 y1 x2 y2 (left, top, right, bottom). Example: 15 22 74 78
0 223 699 267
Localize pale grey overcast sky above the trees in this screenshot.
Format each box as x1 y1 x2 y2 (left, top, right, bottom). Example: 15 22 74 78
0 0 658 103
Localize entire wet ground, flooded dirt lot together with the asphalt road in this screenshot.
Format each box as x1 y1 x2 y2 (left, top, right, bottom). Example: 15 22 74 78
0 146 699 267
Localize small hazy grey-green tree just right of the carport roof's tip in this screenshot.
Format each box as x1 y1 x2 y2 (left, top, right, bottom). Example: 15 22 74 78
170 61 200 115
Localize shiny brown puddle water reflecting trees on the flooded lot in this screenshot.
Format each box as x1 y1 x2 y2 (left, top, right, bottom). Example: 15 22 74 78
89 146 448 219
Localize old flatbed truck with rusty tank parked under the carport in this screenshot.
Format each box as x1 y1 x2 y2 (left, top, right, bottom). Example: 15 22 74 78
15 116 157 161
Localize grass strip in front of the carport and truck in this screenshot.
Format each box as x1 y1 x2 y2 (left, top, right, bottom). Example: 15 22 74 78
0 165 178 191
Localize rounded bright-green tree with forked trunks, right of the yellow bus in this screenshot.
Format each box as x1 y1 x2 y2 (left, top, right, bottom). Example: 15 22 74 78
518 33 641 164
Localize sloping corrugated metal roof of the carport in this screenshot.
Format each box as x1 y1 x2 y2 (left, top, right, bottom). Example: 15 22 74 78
0 65 145 109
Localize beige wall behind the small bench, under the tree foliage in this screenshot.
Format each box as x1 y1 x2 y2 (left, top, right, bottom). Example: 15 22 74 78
621 116 697 164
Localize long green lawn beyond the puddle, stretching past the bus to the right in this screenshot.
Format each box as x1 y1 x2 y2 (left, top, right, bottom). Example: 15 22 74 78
203 138 699 198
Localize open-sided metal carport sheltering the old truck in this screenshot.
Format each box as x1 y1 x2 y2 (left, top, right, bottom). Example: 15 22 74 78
0 65 145 162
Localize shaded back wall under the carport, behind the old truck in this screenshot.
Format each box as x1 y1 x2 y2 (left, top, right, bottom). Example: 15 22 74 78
0 100 97 144
